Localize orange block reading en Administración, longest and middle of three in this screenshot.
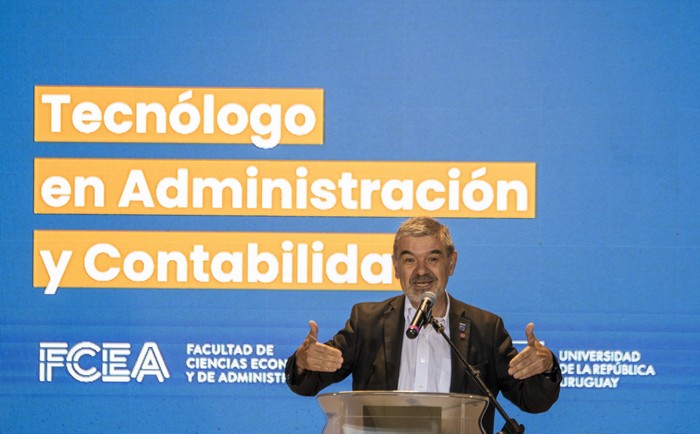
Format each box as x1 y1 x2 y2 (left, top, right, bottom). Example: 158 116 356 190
34 158 536 218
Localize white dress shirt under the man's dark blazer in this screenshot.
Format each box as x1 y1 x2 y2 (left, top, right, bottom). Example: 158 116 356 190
398 297 452 393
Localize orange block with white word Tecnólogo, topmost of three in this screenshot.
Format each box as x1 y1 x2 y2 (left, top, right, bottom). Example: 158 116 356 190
34 86 324 149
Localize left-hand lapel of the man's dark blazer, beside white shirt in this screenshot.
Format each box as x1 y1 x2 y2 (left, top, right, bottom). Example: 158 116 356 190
384 295 406 390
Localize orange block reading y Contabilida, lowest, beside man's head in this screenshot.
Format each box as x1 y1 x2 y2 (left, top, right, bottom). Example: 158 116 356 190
33 230 400 294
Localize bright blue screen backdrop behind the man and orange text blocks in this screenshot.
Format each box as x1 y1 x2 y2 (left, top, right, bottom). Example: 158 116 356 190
0 1 700 434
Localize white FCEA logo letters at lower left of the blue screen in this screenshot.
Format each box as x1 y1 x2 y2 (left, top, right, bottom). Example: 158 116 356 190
39 341 170 383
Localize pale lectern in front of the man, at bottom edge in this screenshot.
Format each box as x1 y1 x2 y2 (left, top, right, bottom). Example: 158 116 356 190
316 391 488 434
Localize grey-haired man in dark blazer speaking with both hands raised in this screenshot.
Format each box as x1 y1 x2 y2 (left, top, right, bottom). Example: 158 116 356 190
286 217 561 433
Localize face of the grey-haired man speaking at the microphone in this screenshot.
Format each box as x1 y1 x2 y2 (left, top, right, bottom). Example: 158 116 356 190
393 236 457 307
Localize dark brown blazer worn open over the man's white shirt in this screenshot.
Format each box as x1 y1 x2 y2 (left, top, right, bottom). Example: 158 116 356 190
286 294 561 433
